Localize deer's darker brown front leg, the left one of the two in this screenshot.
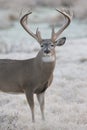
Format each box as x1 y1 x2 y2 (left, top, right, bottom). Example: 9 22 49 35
25 90 35 122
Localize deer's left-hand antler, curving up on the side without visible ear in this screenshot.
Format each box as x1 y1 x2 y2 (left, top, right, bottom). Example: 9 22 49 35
20 12 42 43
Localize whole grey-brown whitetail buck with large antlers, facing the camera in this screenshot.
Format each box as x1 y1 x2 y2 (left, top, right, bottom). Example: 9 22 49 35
0 10 72 121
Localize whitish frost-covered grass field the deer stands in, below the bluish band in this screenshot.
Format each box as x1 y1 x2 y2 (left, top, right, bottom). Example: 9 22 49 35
0 39 87 130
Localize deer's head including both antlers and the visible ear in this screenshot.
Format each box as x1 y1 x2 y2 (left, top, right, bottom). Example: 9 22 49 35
20 9 72 61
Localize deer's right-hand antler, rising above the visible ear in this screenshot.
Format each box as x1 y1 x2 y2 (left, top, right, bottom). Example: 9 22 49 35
51 9 73 42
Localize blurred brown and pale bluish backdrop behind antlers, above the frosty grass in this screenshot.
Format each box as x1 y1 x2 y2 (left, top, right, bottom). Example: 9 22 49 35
0 0 87 53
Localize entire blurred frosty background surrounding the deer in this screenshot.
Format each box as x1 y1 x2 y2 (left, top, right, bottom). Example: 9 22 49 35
0 0 87 130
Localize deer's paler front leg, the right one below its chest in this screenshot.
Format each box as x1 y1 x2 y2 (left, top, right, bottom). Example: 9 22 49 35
37 92 45 120
